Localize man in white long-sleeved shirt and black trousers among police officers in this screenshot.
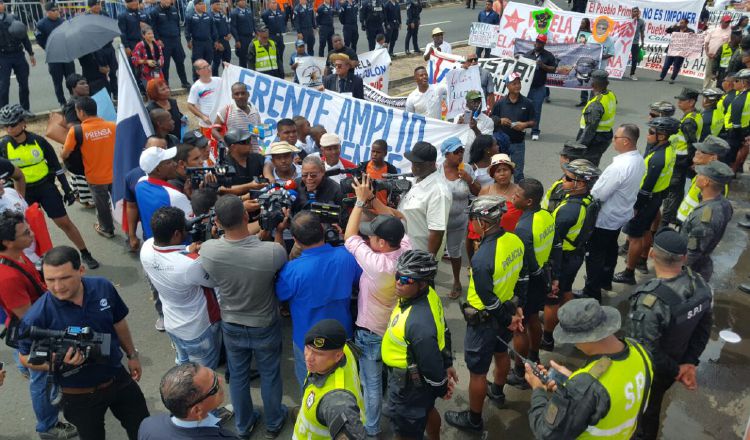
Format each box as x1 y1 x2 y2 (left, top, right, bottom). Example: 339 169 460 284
583 124 646 301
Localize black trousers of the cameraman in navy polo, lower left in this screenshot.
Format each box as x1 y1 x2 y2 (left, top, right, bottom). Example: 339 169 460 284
62 368 149 440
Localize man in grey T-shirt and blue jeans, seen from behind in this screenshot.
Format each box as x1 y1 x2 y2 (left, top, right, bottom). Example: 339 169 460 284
198 195 287 438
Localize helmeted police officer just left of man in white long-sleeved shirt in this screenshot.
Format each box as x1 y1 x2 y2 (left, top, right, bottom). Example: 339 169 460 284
540 159 602 351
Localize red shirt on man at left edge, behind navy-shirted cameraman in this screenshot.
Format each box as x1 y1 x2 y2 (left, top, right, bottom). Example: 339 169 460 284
0 254 47 326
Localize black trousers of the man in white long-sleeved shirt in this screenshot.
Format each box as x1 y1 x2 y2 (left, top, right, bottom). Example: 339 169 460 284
583 228 620 301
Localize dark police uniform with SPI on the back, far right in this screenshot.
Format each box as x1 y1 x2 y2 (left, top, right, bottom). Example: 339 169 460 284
628 269 713 439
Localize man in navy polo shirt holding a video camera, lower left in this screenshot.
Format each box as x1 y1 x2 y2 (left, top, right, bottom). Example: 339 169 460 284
19 246 148 440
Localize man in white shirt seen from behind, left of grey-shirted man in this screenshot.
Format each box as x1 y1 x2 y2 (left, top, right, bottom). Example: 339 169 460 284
141 207 221 368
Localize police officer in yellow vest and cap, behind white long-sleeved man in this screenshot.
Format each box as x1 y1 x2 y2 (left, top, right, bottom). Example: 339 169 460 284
576 69 617 166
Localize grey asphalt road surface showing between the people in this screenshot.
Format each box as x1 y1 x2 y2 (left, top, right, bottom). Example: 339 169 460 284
0 1 750 440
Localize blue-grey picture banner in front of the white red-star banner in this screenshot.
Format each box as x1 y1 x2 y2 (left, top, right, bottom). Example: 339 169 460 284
516 40 602 90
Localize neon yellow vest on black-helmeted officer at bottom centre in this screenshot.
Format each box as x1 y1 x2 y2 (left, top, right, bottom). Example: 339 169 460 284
380 287 445 369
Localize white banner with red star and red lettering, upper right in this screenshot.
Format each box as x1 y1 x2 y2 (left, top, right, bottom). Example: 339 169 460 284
500 2 635 78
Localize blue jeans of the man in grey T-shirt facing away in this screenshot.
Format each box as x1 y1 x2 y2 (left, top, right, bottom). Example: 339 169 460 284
221 320 288 435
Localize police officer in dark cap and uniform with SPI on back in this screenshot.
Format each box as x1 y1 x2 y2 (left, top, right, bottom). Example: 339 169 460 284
627 228 713 439
